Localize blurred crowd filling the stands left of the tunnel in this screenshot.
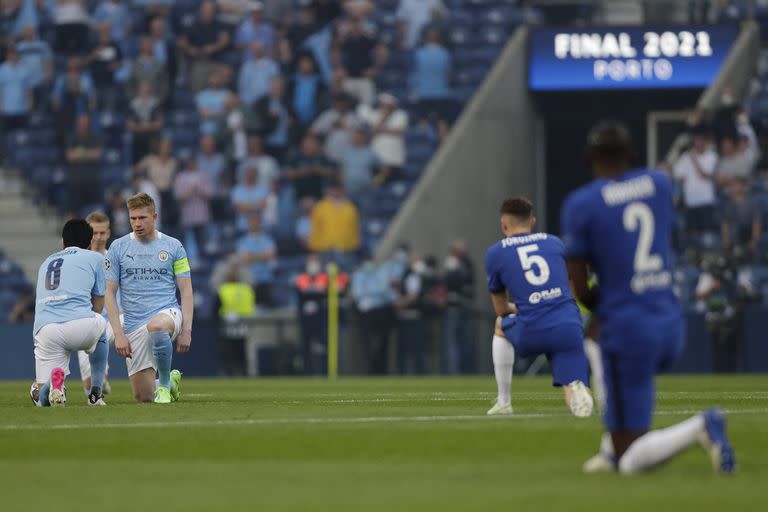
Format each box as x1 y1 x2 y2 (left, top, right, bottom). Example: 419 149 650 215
0 0 486 373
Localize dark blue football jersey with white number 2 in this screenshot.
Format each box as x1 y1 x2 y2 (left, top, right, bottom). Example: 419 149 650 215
561 169 680 324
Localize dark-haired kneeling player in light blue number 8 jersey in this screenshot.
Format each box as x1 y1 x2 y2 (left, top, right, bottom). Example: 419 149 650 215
30 219 107 407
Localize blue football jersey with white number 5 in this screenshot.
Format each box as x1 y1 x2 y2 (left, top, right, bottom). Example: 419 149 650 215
485 233 581 328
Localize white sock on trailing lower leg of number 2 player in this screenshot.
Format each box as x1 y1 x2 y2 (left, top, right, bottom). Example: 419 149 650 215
619 414 705 475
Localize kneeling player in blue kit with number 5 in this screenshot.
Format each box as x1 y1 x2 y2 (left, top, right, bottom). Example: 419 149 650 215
485 197 594 417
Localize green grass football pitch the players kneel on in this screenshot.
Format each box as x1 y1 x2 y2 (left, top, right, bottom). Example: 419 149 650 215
0 376 768 512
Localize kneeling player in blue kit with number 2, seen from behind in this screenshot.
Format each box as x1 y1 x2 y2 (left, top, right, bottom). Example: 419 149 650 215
561 121 735 474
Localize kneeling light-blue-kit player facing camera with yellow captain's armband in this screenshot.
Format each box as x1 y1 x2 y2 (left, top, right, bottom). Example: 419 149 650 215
104 193 194 404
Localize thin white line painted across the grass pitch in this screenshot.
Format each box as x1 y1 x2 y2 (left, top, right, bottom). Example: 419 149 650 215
0 408 768 431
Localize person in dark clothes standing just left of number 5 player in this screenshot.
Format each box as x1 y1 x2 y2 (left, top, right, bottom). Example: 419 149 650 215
443 240 475 375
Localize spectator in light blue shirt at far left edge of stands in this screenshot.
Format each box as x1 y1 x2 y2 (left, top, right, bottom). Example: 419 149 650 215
0 45 32 136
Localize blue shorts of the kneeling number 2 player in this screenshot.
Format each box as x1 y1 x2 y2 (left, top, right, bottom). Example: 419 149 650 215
600 318 683 432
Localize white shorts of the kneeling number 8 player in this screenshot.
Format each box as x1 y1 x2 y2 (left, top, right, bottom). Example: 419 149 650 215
35 313 107 384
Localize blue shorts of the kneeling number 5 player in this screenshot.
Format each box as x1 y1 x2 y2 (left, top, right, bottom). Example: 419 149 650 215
501 315 589 386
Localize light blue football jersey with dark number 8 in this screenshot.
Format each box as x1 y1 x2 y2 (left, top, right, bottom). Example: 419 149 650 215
32 247 105 334
